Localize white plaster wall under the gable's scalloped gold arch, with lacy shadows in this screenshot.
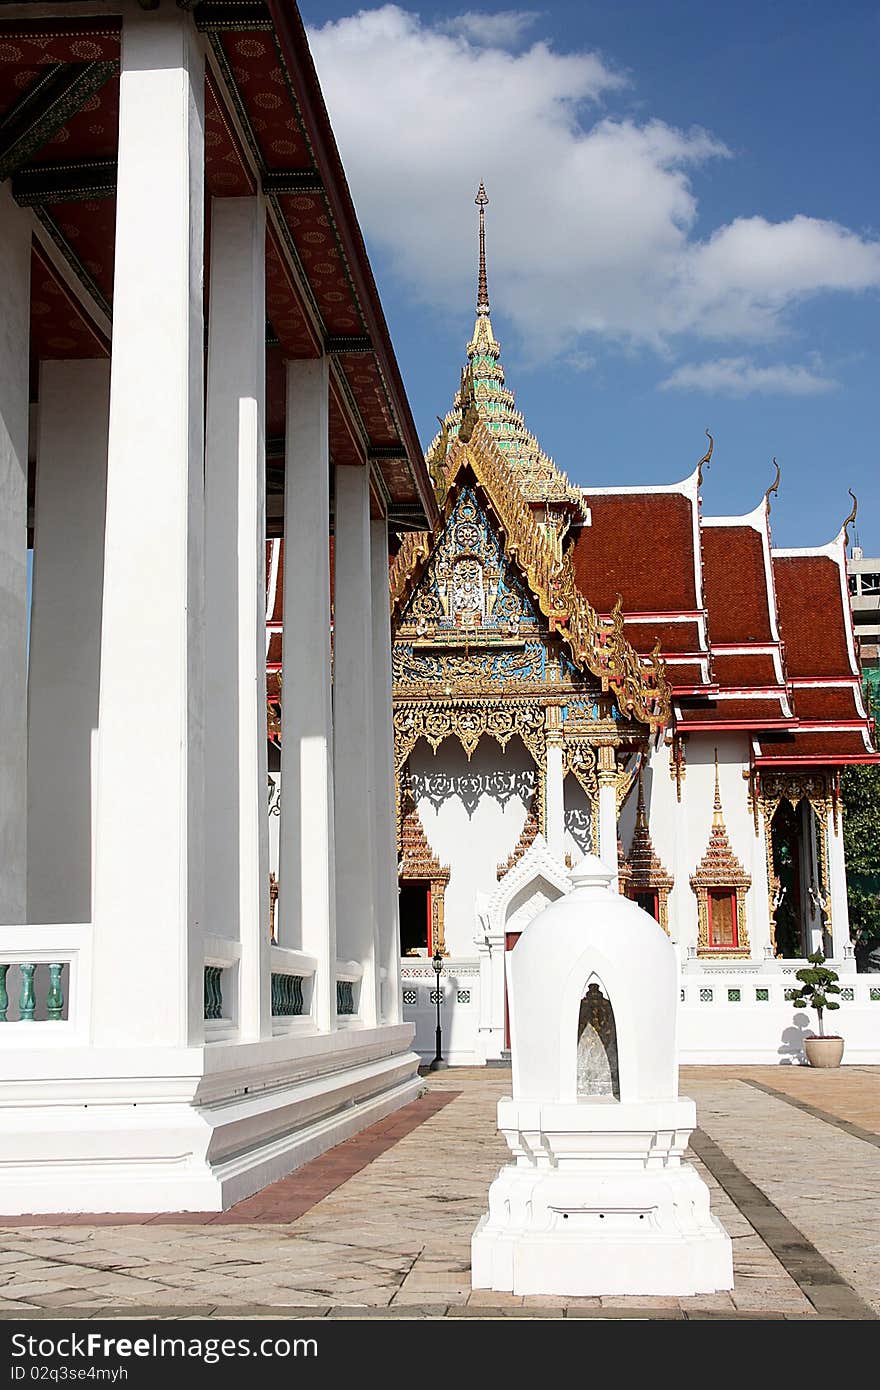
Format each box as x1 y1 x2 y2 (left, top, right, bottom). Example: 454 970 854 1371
409 738 537 956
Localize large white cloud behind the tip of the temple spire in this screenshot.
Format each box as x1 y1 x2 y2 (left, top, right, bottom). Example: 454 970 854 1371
310 4 880 361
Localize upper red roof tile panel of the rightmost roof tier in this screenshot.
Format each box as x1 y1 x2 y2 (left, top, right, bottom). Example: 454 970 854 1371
773 555 855 677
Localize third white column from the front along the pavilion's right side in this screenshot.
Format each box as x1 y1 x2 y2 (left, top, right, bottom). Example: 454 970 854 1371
275 357 336 1030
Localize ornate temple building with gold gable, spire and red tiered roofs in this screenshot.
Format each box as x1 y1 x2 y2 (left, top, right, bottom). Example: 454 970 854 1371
391 188 880 1065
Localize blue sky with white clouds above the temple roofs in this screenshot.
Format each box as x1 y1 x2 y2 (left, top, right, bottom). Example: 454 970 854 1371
302 0 880 555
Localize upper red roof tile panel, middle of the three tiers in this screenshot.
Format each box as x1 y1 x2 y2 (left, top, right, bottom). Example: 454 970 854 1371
702 525 773 642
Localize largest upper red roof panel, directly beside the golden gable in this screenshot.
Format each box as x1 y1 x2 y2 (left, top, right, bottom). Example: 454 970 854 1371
573 492 702 613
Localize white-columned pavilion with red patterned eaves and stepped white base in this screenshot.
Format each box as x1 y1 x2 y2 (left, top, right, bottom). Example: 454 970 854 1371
0 0 437 1213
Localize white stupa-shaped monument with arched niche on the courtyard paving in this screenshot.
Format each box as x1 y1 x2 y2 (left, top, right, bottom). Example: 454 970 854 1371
471 855 733 1297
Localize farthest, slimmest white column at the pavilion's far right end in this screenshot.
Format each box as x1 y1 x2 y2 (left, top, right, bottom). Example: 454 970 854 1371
370 521 403 1023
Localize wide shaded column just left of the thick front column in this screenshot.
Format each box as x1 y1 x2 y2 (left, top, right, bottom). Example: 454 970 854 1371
28 360 110 922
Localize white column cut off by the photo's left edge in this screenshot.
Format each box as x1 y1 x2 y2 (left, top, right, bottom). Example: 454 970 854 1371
0 183 31 924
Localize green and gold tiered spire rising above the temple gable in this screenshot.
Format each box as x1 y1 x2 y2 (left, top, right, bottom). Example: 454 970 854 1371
428 183 585 530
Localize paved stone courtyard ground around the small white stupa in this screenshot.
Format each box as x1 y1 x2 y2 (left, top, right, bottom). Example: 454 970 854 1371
0 1068 880 1322
